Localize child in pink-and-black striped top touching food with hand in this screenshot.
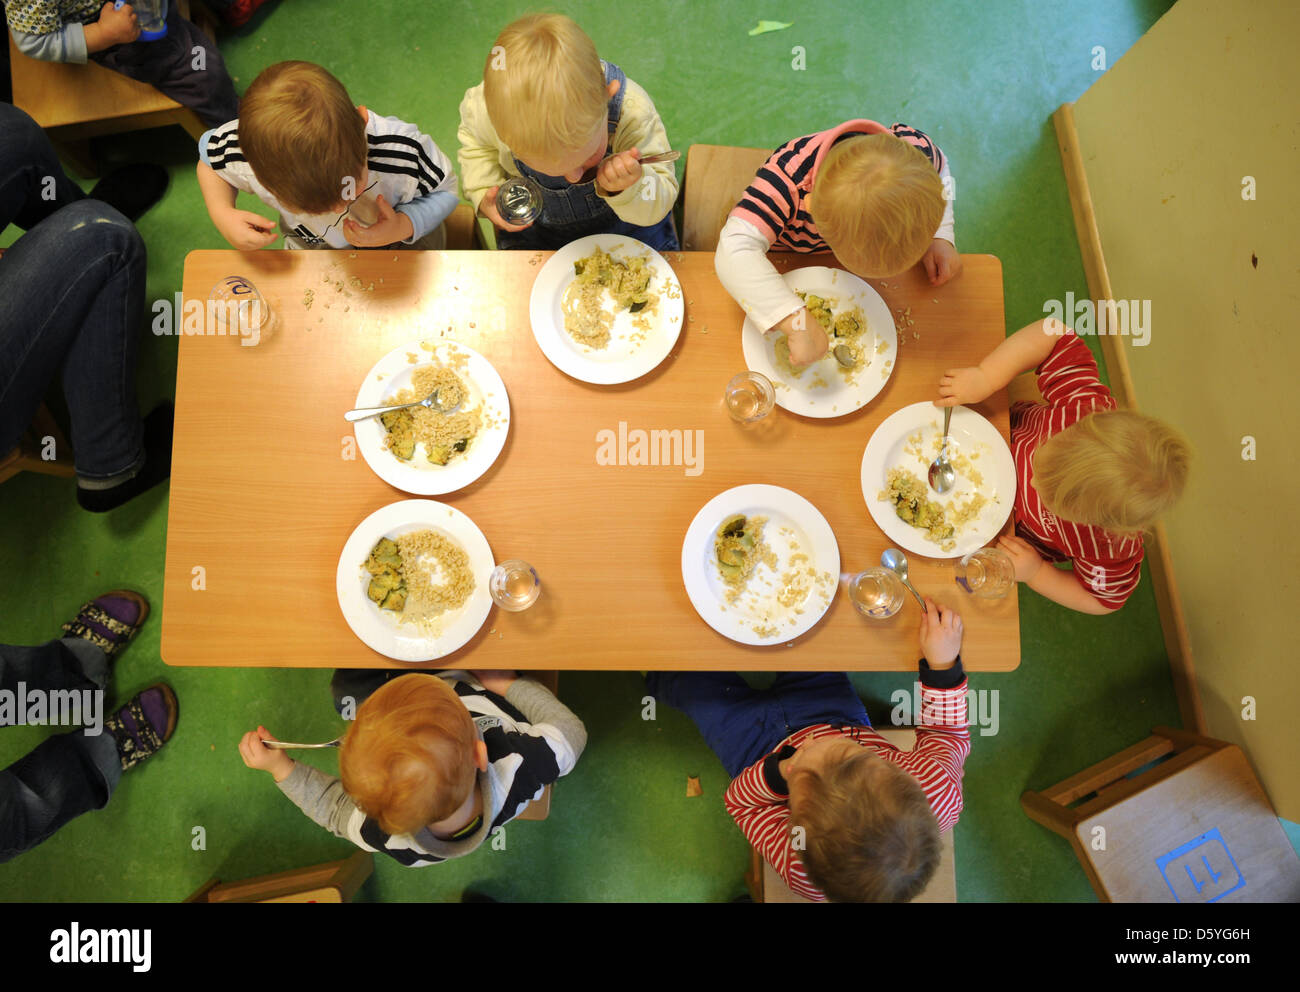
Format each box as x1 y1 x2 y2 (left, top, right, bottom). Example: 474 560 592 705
714 120 962 365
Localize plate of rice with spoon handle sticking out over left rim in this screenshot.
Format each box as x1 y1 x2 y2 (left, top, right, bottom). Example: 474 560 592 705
354 341 510 495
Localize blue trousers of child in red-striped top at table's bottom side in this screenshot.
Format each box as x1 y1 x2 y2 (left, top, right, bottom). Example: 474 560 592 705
646 672 871 779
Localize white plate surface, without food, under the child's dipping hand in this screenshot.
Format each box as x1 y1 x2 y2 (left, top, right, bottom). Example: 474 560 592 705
741 267 898 419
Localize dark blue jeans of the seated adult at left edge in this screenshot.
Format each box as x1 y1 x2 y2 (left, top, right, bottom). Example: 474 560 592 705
0 104 144 480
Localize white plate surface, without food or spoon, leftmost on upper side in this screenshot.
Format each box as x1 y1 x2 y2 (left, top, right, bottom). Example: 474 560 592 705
352 341 510 495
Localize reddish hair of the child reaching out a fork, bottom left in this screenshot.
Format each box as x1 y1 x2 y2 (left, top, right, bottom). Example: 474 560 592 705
338 673 478 833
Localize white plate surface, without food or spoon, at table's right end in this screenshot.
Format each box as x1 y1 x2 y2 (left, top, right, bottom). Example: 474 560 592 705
862 402 1015 558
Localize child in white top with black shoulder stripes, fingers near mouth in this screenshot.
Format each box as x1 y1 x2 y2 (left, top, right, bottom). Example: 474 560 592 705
198 61 459 251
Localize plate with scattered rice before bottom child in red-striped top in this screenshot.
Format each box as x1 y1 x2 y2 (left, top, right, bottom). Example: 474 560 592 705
681 485 840 645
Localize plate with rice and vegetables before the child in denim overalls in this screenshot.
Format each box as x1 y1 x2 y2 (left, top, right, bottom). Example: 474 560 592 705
528 234 685 386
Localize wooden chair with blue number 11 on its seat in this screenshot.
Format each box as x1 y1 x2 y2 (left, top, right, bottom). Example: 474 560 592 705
1021 727 1300 902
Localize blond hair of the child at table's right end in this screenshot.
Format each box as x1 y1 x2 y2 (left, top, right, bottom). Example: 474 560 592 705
1034 410 1192 534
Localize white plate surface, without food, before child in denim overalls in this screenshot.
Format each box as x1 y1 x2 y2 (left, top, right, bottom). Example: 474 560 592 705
528 234 685 386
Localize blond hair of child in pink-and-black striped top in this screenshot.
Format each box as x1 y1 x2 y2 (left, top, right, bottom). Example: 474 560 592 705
810 134 944 278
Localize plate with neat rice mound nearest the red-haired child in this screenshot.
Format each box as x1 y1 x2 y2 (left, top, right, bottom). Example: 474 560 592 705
335 499 495 662
